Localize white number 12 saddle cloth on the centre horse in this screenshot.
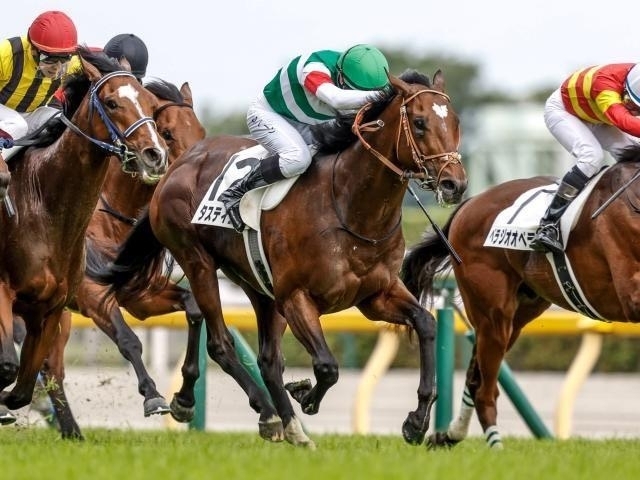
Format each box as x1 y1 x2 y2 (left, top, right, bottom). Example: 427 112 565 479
191 145 298 230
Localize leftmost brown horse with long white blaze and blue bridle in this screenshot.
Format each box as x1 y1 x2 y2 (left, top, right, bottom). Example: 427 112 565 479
0 47 167 420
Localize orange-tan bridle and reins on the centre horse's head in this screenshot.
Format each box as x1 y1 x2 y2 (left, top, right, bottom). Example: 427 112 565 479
351 89 462 191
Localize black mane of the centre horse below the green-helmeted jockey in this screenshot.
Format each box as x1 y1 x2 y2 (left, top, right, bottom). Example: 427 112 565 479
311 69 431 154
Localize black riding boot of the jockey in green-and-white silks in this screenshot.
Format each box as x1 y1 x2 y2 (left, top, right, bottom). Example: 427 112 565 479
218 155 285 232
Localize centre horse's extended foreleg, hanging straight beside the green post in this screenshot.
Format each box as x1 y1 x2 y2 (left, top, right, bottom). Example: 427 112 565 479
358 280 437 445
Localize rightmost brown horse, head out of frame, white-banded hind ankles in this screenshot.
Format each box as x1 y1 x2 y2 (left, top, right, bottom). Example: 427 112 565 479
403 147 640 448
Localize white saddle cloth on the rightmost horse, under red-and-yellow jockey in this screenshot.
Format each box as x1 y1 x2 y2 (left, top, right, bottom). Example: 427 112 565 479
484 169 606 250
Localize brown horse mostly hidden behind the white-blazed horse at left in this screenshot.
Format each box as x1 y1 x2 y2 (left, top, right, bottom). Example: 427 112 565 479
34 79 205 438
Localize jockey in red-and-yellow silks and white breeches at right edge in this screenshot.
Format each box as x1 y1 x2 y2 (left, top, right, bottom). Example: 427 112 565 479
531 63 640 253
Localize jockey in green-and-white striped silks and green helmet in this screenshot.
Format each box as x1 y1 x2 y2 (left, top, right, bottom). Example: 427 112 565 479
219 45 389 232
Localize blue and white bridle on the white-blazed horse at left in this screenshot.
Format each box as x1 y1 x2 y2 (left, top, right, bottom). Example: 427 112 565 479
60 71 155 175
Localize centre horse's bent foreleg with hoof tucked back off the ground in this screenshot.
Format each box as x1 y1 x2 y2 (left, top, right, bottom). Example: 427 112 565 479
282 292 339 415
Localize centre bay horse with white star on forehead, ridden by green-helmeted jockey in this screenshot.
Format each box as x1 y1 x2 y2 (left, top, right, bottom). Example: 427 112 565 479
90 71 467 447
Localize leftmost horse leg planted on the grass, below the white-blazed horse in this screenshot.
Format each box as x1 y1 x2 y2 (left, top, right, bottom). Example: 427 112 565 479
39 310 84 440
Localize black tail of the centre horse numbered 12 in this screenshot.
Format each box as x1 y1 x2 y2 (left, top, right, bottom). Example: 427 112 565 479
85 211 169 303
